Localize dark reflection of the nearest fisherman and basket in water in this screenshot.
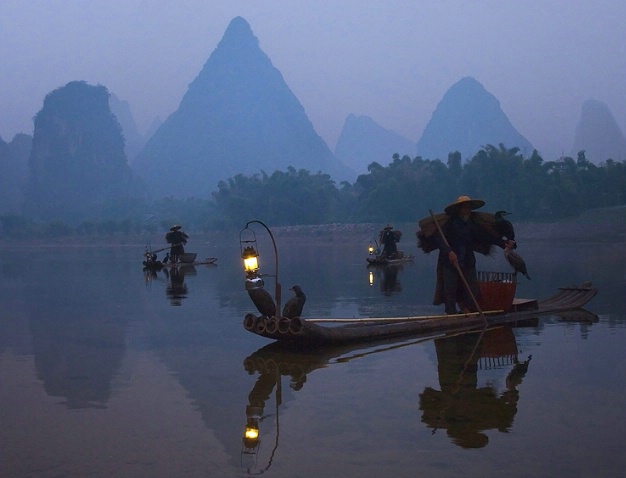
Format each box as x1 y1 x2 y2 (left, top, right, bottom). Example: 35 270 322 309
420 328 530 448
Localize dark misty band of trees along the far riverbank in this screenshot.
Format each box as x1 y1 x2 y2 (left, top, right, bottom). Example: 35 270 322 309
0 144 626 240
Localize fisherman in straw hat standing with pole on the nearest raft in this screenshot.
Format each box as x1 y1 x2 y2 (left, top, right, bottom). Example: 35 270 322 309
434 196 515 314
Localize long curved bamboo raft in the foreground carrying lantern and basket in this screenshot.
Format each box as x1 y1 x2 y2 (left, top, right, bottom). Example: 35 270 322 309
243 284 598 345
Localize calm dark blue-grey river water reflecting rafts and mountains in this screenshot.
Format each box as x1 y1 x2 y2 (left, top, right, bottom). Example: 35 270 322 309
0 230 626 478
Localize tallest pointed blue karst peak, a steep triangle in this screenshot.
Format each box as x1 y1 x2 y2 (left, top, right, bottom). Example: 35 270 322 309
132 17 353 197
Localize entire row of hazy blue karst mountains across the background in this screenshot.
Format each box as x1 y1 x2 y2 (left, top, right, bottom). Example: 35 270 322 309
0 17 626 217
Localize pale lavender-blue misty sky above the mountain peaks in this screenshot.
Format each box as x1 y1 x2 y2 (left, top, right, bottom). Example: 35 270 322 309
0 0 626 160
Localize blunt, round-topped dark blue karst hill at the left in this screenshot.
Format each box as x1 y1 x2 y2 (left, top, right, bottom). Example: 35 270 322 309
25 81 139 220
